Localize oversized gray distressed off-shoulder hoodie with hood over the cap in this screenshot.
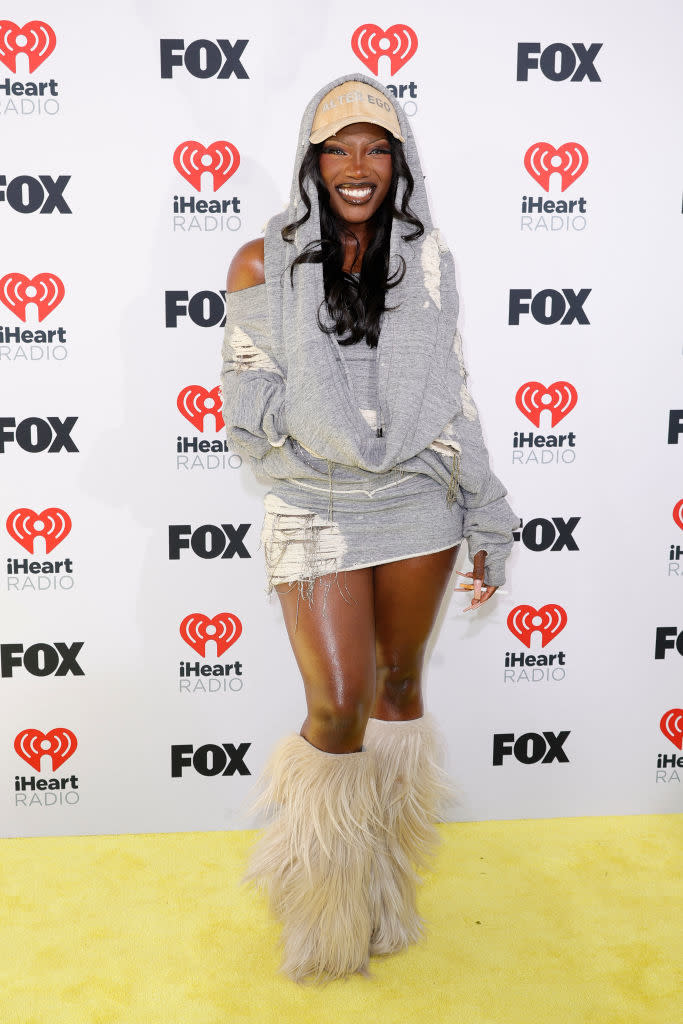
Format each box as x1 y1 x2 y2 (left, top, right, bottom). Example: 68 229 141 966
221 74 519 586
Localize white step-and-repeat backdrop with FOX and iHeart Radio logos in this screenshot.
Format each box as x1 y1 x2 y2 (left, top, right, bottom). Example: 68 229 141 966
0 0 683 836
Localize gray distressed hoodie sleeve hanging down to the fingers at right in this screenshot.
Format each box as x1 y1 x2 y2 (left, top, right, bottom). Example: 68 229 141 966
430 332 520 587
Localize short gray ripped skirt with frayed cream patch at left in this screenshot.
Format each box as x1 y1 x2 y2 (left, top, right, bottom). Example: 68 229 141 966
261 462 463 602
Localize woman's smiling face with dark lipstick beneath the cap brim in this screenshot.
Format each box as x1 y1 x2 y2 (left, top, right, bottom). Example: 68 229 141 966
318 122 392 227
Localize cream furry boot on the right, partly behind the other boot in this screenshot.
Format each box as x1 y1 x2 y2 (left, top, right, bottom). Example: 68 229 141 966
364 715 453 955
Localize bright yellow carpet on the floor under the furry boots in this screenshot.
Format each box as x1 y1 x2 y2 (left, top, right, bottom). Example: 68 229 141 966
0 815 683 1024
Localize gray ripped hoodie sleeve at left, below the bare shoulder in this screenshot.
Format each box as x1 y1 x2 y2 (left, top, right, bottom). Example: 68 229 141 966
220 285 288 459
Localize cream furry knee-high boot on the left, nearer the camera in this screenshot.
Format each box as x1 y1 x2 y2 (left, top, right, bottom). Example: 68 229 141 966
245 735 379 981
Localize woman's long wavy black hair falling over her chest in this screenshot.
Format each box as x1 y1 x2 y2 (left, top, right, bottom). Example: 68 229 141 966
282 135 425 348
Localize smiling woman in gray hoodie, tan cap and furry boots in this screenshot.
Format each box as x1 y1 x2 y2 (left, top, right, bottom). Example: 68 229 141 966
221 75 519 980
